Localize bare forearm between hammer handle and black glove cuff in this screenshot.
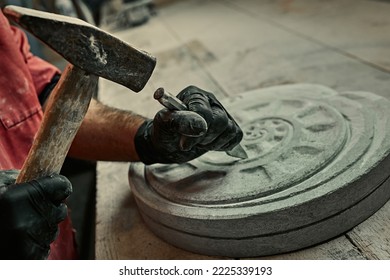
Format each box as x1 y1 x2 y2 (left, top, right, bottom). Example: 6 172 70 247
69 99 145 161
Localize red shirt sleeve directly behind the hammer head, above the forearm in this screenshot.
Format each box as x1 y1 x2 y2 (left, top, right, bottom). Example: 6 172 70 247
11 26 60 94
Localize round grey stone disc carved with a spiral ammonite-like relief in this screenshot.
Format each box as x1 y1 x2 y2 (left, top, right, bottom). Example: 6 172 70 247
129 84 390 257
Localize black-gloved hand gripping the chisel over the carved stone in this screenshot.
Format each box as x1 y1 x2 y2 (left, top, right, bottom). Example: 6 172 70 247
135 86 243 164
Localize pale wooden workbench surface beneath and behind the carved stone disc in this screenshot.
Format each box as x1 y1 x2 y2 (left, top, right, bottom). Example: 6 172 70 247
95 0 390 260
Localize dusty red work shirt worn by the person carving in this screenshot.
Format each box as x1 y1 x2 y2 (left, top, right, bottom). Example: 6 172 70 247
0 10 76 259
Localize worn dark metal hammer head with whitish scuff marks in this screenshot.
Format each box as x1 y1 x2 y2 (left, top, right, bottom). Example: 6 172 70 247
3 6 156 92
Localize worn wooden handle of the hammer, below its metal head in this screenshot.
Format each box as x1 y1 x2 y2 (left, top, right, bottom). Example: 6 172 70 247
16 64 98 183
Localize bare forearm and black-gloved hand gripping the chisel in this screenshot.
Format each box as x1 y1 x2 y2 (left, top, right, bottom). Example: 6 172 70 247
69 86 242 164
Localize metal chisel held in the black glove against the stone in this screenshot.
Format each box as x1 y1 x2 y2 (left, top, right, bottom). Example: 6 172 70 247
154 88 248 159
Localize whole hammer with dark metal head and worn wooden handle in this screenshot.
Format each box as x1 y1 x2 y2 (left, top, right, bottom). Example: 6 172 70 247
3 6 156 183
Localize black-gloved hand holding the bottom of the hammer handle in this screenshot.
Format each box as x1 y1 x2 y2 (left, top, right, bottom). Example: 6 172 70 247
0 170 72 259
